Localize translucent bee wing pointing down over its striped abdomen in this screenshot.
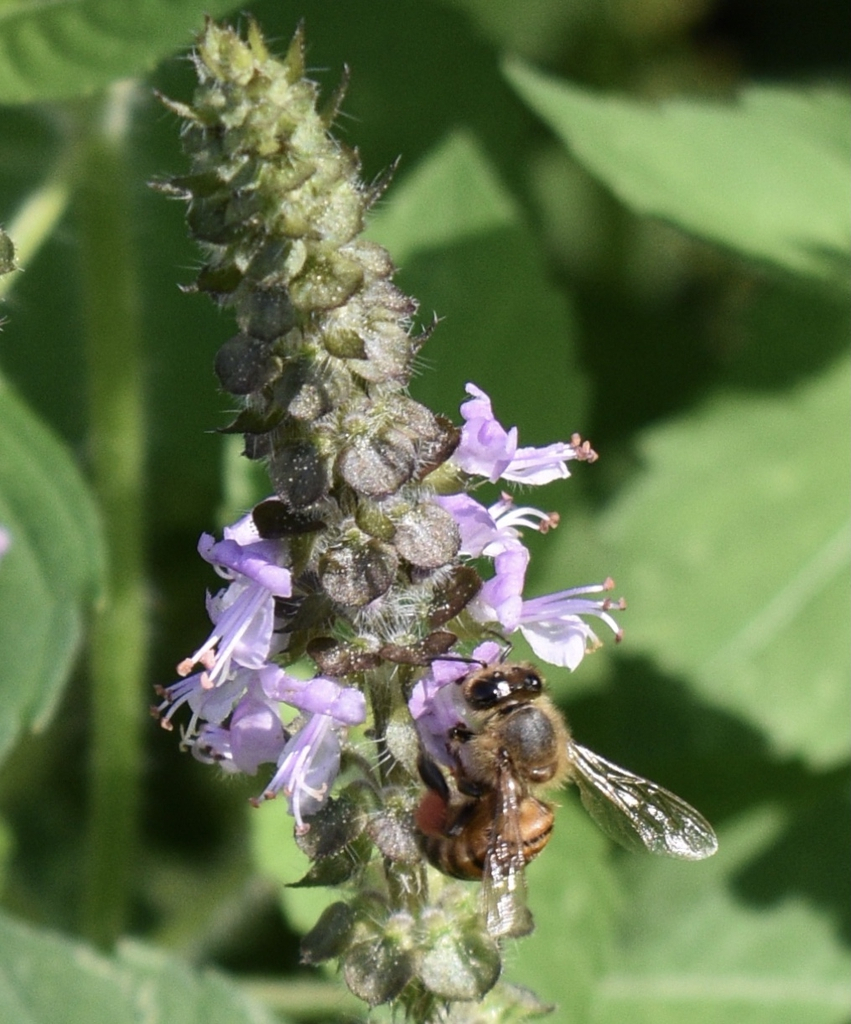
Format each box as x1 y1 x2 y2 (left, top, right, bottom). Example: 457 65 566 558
481 771 534 937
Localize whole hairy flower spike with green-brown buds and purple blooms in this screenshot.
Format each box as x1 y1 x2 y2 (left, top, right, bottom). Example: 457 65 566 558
156 23 618 1020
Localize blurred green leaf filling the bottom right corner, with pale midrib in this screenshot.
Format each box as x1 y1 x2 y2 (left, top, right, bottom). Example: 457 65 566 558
591 809 851 1024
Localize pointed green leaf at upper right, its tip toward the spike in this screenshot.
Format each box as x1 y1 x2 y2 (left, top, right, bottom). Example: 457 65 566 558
505 60 851 278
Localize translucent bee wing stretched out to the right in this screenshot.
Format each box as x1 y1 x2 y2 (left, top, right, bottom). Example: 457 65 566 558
567 740 718 860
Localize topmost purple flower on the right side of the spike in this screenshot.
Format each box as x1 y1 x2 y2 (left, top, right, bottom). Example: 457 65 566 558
452 384 597 486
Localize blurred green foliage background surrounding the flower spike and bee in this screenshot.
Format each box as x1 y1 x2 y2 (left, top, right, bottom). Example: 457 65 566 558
0 0 851 1024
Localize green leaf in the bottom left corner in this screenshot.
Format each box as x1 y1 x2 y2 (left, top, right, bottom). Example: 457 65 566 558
0 916 284 1024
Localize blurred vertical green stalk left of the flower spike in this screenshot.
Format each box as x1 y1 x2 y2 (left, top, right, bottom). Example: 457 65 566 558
78 83 147 946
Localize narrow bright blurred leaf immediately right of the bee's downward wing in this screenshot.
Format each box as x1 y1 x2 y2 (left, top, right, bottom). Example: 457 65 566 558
506 793 622 1021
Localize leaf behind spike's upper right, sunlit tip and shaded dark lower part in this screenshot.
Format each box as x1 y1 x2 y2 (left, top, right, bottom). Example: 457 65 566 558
370 133 585 443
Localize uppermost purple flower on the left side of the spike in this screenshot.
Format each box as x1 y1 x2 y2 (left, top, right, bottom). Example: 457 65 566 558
177 515 292 686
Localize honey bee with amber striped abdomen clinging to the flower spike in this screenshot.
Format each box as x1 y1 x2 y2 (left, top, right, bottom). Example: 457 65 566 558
417 663 718 936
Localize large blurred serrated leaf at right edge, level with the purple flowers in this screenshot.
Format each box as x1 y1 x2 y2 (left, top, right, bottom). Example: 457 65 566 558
599 360 851 767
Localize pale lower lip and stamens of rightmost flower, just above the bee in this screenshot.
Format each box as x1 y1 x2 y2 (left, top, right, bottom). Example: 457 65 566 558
518 580 626 671
